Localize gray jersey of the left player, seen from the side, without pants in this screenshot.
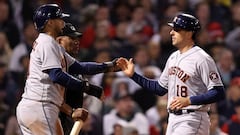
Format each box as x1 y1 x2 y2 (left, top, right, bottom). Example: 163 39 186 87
22 33 75 105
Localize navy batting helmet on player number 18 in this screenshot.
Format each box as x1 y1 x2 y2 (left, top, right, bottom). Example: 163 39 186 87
168 13 201 32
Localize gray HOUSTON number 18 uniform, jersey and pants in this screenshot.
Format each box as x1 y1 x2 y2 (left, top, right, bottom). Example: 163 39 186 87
158 46 223 135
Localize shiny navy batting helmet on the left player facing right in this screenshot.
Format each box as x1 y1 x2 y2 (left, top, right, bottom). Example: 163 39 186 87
33 4 69 31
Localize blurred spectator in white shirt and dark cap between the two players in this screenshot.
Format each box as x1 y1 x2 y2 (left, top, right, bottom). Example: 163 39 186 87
103 79 149 135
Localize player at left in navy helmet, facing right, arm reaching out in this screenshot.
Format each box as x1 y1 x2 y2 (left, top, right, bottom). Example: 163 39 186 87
16 4 118 135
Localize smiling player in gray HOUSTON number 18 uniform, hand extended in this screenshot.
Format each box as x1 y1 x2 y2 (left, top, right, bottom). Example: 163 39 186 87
117 13 225 135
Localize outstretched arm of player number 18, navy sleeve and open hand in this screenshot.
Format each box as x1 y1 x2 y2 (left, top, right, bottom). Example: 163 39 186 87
117 58 167 96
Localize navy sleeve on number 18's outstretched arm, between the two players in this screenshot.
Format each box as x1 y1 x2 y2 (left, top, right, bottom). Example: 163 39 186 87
131 73 168 96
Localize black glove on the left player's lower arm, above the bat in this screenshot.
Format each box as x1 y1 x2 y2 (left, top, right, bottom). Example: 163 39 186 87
83 80 103 99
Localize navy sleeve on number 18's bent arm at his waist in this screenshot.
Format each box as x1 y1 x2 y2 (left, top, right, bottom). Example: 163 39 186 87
190 86 225 105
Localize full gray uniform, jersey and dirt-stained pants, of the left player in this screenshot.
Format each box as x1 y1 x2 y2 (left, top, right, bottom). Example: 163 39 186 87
17 33 75 135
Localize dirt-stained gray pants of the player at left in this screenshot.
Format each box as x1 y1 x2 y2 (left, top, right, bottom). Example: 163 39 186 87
17 99 62 135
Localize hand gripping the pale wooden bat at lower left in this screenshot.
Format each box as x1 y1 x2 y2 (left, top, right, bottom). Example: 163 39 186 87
72 108 88 121
